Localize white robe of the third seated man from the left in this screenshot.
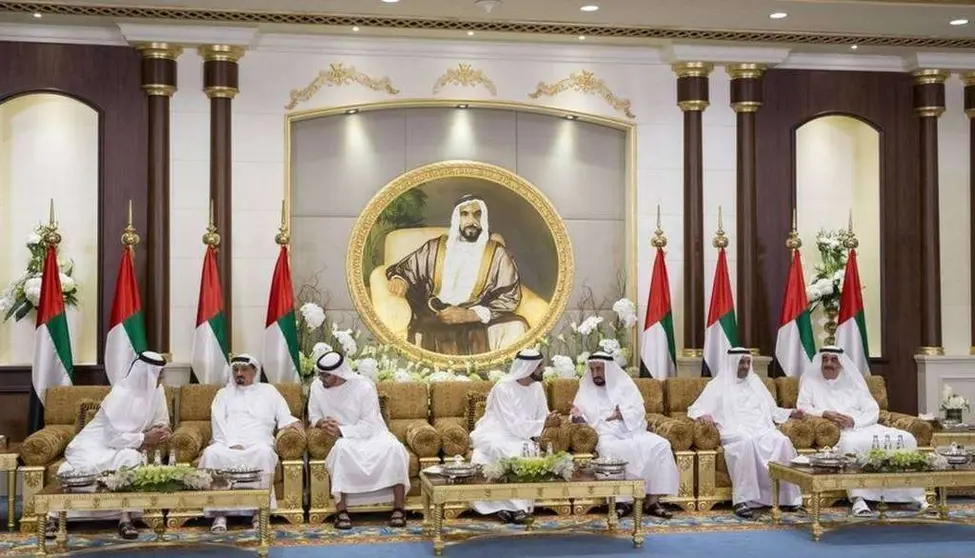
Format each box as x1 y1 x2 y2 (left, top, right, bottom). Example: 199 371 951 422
308 378 410 506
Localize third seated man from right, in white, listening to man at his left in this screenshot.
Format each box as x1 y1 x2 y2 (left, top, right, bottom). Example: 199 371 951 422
572 352 678 519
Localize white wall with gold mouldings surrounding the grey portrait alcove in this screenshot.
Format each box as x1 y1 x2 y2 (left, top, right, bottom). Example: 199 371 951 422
171 36 735 362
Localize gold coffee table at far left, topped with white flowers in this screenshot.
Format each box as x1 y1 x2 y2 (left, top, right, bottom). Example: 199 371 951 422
34 483 271 556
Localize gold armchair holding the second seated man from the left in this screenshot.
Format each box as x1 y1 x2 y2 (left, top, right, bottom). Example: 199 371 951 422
166 384 306 528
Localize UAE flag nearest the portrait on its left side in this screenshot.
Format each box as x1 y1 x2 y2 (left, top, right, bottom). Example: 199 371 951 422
264 246 301 384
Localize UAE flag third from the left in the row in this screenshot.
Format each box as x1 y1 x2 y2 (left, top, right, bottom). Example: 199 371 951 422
190 246 230 384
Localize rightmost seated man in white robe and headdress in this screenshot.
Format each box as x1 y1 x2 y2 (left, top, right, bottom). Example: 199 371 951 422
797 347 928 517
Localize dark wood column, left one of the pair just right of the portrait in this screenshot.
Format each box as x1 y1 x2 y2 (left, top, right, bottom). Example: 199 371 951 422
674 62 713 357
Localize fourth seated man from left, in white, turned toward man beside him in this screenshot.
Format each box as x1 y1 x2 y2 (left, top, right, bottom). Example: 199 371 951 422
471 349 561 524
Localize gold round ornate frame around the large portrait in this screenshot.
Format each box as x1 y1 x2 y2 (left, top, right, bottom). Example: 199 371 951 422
345 161 575 369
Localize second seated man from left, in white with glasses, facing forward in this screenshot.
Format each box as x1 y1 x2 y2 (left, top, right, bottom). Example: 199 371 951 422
200 354 301 533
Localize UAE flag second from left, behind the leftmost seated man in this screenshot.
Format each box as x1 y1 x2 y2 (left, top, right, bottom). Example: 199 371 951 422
105 248 149 384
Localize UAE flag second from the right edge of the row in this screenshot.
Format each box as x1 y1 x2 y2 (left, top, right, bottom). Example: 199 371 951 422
775 250 816 377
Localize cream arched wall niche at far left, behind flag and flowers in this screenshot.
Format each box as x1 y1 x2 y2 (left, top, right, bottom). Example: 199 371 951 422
0 94 98 365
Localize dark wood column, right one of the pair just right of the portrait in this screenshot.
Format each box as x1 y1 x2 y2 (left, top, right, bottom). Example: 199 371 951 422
727 64 765 354
